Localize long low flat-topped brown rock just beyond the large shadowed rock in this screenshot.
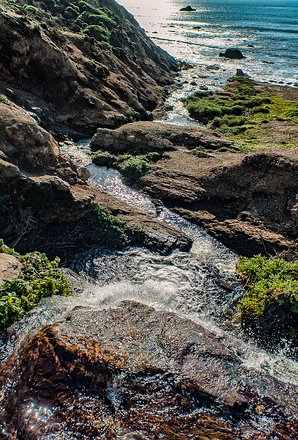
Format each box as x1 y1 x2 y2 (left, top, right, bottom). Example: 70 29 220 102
91 122 233 154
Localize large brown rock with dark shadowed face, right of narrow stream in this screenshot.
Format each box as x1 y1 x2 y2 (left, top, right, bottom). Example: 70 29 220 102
142 149 298 255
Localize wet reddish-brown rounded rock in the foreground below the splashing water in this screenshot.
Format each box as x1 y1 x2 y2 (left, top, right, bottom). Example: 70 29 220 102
0 302 298 440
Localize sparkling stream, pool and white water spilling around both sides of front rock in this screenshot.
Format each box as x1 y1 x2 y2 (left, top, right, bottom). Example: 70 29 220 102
0 136 298 439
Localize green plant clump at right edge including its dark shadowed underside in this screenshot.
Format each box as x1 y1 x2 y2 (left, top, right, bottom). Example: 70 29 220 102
237 255 298 340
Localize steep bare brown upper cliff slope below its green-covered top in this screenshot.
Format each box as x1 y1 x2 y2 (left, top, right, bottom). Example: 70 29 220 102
0 0 177 134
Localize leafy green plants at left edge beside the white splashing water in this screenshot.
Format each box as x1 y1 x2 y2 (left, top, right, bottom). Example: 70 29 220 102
0 240 72 329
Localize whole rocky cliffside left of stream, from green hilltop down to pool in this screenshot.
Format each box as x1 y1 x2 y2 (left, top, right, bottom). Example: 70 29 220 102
0 0 188 255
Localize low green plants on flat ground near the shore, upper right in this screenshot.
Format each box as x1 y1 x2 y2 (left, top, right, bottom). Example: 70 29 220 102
186 77 298 150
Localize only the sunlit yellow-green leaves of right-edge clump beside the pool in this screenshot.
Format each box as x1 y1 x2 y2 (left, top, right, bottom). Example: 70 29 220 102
237 255 298 322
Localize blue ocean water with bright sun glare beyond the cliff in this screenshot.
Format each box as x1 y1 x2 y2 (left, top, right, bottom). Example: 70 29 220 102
118 0 298 89
